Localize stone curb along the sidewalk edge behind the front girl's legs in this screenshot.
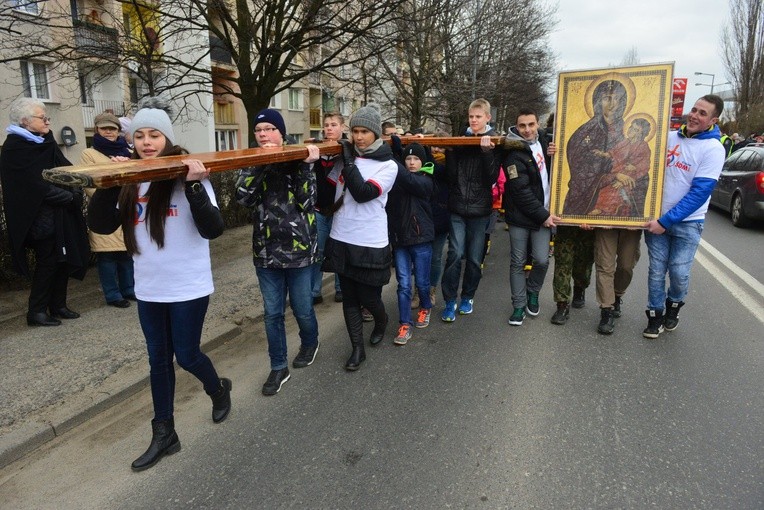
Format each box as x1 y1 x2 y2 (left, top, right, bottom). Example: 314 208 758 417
0 325 241 469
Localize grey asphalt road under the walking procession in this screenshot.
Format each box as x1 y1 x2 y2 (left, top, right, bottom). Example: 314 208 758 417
0 218 764 509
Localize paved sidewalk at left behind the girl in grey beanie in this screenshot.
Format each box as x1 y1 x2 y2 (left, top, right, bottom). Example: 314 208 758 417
0 226 262 468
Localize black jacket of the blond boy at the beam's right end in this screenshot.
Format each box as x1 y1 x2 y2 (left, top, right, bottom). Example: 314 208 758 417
446 129 502 218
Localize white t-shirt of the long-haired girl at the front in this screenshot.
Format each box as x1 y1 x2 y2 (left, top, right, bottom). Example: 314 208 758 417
133 180 217 303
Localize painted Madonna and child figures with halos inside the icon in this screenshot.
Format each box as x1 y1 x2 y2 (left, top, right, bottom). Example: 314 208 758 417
562 73 656 218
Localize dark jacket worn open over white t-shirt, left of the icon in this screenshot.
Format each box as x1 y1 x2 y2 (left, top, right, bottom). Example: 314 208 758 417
504 128 551 230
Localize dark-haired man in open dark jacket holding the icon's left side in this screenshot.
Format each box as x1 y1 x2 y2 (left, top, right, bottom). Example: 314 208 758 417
504 109 559 326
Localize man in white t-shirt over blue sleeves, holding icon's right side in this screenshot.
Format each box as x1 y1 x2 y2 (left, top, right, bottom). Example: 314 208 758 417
642 94 724 338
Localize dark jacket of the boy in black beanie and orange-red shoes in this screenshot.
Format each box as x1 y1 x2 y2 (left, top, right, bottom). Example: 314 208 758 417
385 165 435 248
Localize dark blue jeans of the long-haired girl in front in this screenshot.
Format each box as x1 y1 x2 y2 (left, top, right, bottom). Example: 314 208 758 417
138 296 220 421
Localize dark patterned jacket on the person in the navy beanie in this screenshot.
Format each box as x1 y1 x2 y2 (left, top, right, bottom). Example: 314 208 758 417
236 151 318 269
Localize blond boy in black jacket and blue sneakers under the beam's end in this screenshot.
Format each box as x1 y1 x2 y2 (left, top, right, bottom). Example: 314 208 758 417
441 99 501 322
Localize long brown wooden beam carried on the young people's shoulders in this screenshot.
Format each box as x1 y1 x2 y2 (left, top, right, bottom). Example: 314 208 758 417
42 136 504 188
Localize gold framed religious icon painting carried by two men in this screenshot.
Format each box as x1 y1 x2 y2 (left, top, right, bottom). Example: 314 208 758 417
551 64 673 227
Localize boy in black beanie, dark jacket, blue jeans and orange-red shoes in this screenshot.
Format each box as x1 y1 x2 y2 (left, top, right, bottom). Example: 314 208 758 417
386 143 435 345
